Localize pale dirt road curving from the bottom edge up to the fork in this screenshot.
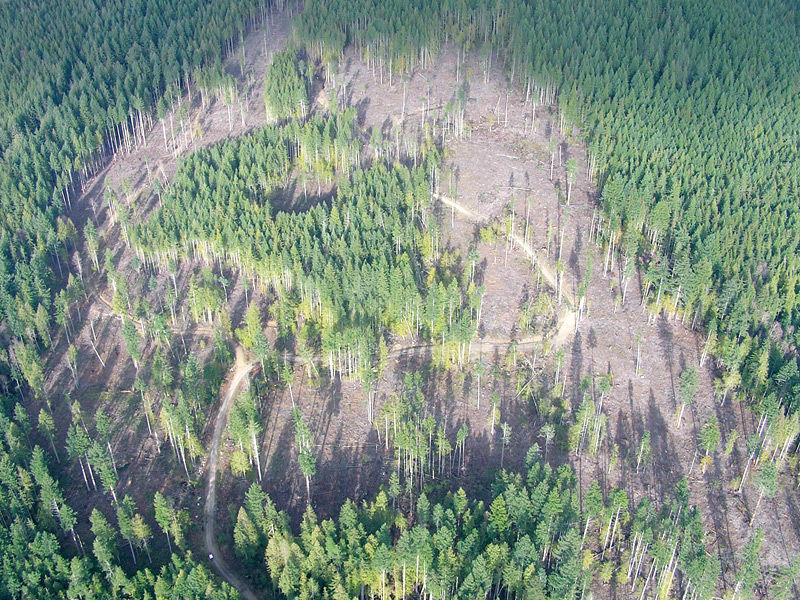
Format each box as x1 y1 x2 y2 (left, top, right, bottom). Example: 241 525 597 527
204 347 257 600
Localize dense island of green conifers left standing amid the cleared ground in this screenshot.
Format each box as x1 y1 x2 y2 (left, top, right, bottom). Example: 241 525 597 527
131 109 478 375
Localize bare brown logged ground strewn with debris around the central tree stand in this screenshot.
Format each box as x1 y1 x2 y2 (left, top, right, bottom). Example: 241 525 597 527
45 4 800 596
